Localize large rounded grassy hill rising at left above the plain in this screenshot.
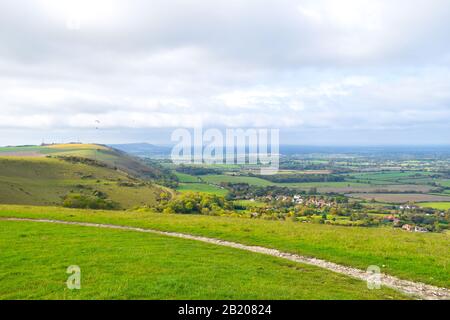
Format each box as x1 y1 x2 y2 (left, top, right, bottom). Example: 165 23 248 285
0 145 167 209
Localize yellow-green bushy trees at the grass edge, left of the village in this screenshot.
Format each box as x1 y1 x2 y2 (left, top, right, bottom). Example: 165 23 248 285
156 192 234 215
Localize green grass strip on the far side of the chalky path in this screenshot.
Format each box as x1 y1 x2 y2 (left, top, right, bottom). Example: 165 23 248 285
0 206 450 288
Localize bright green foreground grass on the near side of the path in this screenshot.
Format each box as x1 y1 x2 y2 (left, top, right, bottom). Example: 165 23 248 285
0 221 406 299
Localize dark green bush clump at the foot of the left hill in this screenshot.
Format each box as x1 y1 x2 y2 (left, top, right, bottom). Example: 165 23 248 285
62 191 120 210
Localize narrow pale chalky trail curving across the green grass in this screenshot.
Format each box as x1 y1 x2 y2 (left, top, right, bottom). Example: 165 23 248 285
0 218 450 300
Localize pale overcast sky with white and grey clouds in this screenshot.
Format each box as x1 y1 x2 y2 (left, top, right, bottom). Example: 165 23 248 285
0 0 450 145
